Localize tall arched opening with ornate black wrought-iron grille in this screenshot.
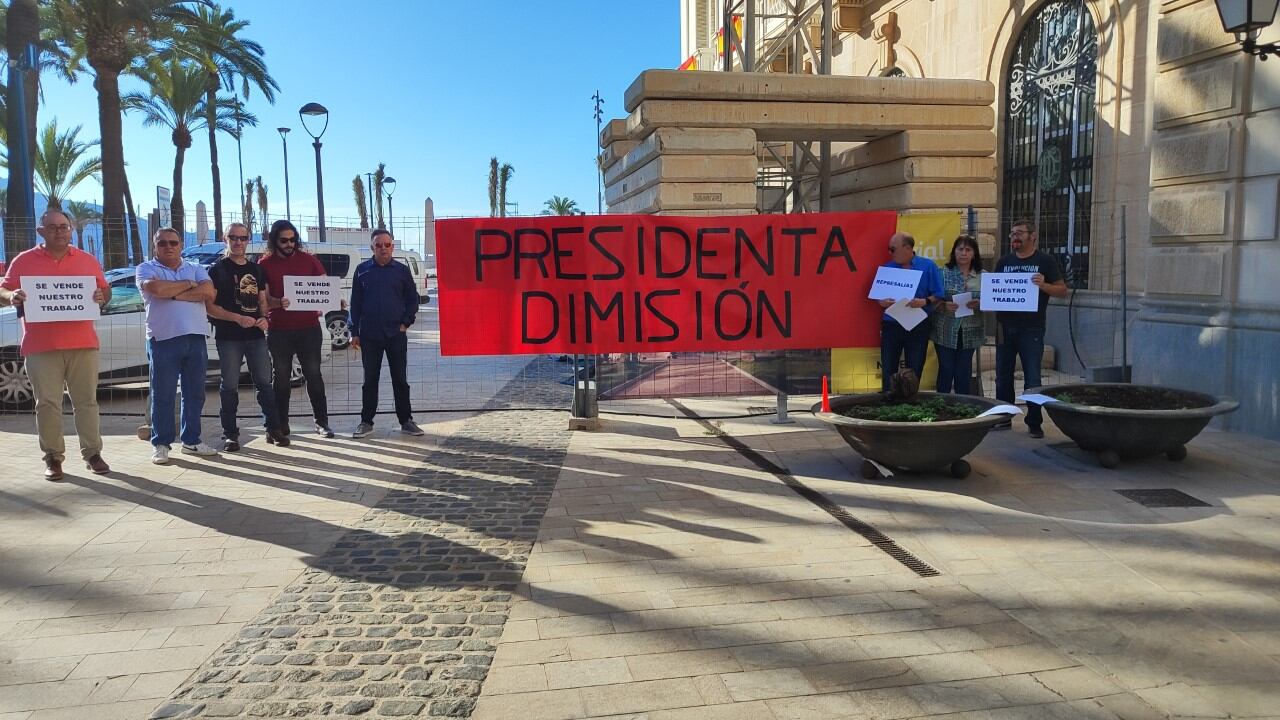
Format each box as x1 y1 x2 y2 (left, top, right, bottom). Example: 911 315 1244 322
1001 0 1098 288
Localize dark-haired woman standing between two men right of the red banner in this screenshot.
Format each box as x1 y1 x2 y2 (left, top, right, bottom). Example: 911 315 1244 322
932 234 986 395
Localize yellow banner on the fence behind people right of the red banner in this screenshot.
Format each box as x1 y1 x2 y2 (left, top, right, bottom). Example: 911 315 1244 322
831 213 964 393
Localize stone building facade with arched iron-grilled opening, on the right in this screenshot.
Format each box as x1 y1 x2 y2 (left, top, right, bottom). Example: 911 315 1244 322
681 0 1280 438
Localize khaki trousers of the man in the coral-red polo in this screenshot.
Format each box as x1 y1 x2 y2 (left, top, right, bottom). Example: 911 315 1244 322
27 348 102 462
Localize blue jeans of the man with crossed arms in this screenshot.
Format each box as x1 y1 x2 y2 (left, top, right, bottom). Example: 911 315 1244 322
147 334 209 446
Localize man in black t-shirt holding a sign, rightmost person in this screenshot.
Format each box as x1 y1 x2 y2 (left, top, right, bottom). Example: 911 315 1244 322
996 220 1070 438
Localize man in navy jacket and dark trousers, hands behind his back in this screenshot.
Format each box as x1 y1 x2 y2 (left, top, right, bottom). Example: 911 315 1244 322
349 229 422 438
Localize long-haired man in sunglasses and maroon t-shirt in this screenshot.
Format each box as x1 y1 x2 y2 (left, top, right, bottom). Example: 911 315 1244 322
257 220 333 437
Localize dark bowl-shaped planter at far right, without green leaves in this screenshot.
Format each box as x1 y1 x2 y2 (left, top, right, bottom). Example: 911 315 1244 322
1037 383 1240 468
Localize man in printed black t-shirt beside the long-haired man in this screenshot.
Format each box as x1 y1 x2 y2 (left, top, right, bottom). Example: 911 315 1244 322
205 223 289 452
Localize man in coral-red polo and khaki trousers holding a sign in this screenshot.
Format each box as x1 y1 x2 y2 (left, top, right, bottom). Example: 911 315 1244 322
0 210 111 480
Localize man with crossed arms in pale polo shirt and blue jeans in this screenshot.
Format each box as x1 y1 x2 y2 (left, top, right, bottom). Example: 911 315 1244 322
137 228 218 465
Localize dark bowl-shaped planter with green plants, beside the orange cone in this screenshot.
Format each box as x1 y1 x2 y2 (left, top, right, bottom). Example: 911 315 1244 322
812 392 1009 480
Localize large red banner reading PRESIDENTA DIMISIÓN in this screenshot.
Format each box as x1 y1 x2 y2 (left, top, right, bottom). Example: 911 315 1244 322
436 213 897 355
